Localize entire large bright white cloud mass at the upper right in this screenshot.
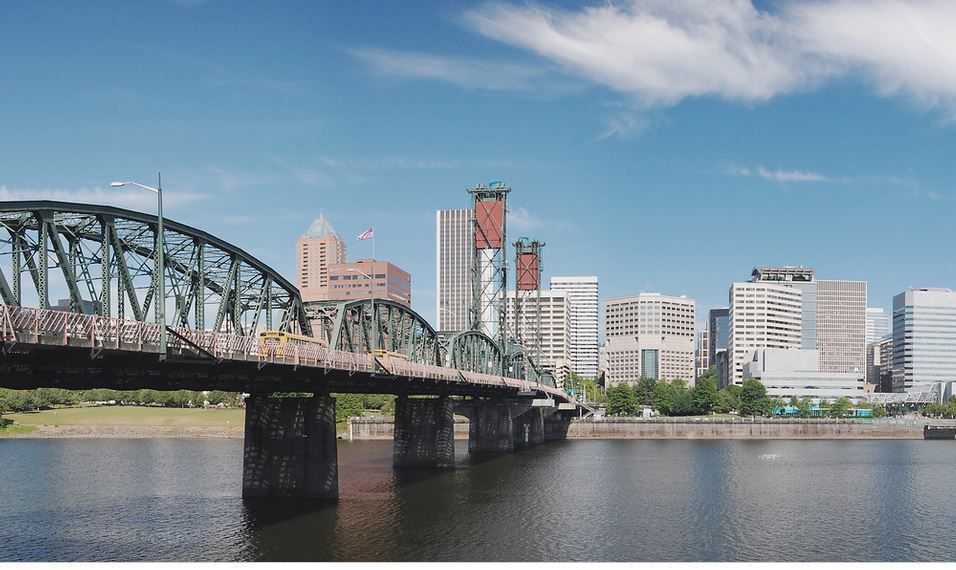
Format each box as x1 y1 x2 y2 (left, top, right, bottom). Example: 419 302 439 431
450 0 956 117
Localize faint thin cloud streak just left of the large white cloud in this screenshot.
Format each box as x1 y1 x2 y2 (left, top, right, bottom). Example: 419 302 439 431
350 48 545 91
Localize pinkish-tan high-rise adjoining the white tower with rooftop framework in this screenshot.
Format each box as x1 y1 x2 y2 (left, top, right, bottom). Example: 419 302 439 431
817 279 866 374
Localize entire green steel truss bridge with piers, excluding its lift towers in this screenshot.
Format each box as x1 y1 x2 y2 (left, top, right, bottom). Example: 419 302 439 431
0 201 590 497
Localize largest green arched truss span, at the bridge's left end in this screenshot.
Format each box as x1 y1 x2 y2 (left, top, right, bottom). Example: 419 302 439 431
0 201 311 335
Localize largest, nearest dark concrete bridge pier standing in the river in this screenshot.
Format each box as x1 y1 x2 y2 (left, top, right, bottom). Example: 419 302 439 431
242 394 339 499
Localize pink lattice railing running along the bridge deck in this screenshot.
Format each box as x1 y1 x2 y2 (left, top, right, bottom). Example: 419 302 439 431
0 305 576 403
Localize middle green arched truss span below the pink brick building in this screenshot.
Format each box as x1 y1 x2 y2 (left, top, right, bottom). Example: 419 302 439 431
305 299 442 366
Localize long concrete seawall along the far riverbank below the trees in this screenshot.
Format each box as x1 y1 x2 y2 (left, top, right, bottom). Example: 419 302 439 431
349 418 923 439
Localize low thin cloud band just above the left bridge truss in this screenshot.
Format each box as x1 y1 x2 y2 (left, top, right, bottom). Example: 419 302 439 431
0 184 208 211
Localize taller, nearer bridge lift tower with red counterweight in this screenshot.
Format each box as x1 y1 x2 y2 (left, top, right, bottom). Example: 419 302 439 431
468 182 511 360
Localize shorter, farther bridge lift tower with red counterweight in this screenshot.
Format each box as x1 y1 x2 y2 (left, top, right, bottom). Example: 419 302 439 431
514 237 544 367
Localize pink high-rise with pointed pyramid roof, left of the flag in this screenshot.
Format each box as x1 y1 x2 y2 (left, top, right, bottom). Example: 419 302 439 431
296 214 345 301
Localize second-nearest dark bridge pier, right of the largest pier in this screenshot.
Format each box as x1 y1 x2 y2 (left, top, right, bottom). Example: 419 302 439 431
392 396 455 467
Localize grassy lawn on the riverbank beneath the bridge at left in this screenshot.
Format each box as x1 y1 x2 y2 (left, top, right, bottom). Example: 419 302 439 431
3 406 245 426
